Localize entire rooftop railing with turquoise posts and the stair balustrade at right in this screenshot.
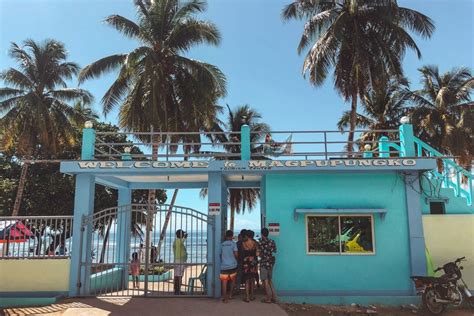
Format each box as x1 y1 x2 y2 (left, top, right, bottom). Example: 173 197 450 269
77 119 474 205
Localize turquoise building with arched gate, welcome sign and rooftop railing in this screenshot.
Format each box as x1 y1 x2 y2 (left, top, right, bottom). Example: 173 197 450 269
54 118 474 304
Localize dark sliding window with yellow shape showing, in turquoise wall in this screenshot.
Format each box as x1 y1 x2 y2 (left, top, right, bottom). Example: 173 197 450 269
306 215 374 254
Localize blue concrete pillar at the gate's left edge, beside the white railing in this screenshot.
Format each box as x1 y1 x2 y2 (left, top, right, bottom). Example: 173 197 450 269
69 174 95 296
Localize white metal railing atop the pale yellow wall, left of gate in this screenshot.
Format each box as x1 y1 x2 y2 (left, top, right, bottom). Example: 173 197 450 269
0 216 73 260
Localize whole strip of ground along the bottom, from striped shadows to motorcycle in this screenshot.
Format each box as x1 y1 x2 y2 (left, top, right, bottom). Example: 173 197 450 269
0 295 474 316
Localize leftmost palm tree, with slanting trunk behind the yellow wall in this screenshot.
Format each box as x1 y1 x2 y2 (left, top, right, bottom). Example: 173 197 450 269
0 40 93 216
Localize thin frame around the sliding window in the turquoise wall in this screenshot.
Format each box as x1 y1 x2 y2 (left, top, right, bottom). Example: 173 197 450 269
304 213 377 256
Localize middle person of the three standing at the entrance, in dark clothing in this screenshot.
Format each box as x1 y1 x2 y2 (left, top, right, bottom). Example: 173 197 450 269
242 231 258 303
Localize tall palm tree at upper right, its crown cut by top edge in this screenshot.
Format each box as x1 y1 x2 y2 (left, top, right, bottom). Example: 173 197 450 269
282 0 434 153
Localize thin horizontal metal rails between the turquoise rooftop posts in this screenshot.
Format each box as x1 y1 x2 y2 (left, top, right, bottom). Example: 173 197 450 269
90 130 400 160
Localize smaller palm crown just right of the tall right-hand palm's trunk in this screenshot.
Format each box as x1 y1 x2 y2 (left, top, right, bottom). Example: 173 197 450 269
337 79 409 148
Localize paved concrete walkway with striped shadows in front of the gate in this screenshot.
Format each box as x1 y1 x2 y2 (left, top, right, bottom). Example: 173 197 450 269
5 297 287 316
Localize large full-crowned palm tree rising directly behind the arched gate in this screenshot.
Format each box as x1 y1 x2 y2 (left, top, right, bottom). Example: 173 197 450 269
79 0 226 260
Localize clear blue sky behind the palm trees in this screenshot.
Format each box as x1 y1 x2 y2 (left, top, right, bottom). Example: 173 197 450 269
0 0 474 229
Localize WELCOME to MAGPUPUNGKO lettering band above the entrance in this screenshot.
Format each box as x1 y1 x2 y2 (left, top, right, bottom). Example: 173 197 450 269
77 158 417 170
